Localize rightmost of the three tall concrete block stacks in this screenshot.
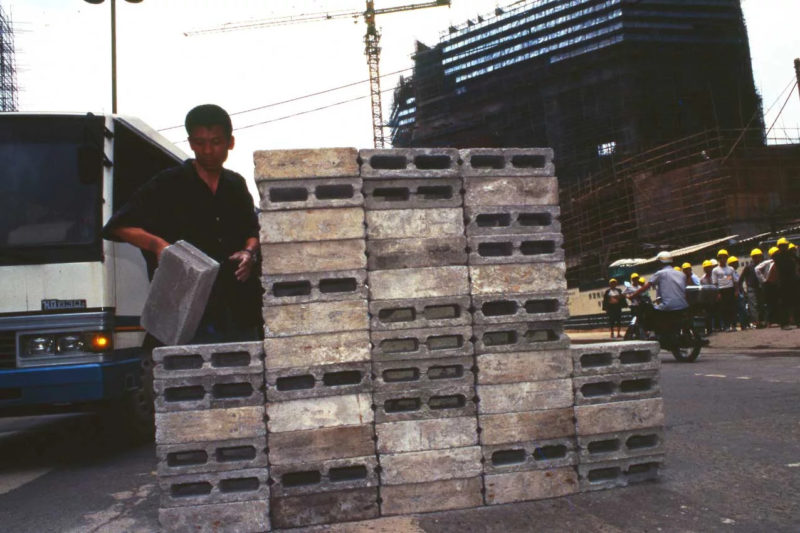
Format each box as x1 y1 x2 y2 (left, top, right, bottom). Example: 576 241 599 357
461 148 578 504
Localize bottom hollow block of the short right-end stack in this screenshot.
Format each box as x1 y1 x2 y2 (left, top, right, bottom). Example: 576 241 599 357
578 455 664 492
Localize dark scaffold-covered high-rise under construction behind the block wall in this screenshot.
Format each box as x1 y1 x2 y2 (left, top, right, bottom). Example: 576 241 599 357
391 0 800 286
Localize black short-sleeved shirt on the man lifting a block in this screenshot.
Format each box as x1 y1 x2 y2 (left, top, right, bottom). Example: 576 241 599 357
103 159 261 321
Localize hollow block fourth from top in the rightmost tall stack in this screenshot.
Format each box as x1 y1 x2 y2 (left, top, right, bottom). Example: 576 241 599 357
467 233 564 265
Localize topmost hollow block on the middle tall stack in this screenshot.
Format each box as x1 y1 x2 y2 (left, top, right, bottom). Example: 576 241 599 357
358 148 460 178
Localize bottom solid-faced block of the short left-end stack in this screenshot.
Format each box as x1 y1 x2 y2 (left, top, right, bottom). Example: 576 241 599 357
158 500 270 533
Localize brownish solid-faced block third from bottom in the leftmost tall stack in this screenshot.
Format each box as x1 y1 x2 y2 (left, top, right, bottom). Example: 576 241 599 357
269 424 375 466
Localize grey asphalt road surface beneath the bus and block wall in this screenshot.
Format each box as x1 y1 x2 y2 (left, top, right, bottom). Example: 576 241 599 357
0 342 800 533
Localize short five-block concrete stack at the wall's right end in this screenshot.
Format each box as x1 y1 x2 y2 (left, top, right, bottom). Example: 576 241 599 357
572 342 664 491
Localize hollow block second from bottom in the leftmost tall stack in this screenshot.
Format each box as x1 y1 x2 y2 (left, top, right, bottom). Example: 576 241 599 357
270 451 378 498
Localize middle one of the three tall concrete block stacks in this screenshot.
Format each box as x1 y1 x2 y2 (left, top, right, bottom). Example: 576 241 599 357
360 148 483 515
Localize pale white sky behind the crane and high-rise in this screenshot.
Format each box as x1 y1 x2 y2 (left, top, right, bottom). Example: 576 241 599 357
6 0 800 195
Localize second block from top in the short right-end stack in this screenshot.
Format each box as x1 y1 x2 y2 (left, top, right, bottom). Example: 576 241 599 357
573 370 661 405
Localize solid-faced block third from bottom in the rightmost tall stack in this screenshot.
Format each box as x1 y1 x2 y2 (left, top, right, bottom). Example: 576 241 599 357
478 407 575 446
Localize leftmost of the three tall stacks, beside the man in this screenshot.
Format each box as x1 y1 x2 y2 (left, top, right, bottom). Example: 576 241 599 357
255 148 379 528
